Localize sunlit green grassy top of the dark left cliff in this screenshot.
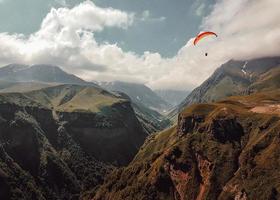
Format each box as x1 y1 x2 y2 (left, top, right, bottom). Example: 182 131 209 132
0 85 125 112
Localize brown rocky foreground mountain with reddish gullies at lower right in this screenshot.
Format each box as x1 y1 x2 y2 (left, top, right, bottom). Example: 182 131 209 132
91 89 280 200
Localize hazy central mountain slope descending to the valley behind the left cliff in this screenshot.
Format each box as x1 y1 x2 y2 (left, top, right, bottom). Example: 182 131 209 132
99 81 171 133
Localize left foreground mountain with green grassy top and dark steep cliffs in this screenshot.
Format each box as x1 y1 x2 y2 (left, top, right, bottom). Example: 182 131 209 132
0 85 147 200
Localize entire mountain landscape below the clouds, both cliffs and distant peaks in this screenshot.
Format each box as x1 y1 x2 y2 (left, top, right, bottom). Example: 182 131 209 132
0 57 280 200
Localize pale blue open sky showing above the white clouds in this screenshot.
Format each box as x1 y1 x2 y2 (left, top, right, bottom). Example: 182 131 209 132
0 0 214 57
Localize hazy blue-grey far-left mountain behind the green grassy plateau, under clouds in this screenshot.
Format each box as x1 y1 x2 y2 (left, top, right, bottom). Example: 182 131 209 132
0 64 95 85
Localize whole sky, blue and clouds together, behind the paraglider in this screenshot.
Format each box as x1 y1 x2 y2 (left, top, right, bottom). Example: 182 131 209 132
0 0 280 90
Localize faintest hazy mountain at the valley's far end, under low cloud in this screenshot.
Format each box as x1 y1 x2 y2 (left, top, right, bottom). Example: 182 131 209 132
154 90 190 106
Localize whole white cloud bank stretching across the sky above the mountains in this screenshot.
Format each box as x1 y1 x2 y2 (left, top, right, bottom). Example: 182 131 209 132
0 0 280 89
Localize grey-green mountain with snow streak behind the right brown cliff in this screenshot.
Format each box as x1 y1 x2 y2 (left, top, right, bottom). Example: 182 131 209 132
169 57 280 118
